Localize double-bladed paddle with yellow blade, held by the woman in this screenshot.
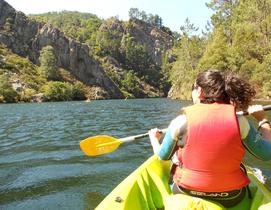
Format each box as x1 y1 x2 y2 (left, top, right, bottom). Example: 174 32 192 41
80 105 271 156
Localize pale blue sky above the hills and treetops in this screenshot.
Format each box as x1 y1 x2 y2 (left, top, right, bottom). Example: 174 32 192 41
3 0 212 31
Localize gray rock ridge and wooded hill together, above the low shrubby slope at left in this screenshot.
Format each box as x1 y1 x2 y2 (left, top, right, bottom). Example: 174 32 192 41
0 0 173 99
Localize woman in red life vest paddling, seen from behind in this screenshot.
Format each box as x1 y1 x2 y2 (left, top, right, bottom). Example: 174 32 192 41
149 70 271 207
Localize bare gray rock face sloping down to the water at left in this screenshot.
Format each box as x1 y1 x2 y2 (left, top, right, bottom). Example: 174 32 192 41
0 0 123 98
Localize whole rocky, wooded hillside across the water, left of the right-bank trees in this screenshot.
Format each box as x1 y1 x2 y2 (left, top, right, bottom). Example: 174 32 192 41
0 2 173 102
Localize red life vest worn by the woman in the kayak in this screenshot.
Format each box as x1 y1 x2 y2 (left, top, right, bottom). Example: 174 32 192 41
173 103 250 192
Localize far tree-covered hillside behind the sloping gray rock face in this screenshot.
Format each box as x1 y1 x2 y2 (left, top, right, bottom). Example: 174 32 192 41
31 11 172 97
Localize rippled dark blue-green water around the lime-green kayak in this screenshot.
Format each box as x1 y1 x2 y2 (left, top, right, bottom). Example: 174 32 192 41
0 99 271 209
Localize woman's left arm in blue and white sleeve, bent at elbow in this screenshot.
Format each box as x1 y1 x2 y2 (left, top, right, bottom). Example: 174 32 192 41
149 115 187 160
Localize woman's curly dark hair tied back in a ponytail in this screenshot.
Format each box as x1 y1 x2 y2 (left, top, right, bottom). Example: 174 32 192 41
196 69 256 110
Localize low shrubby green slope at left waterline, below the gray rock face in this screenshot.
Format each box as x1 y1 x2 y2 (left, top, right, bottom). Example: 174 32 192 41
0 45 92 103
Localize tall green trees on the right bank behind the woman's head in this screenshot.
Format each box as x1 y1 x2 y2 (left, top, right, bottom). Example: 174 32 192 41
169 0 271 99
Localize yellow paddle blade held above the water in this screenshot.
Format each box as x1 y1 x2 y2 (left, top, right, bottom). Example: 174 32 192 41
80 136 122 156
